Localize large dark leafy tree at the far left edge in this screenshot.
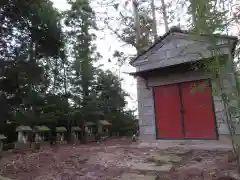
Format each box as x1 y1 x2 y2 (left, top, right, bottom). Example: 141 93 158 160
0 0 64 142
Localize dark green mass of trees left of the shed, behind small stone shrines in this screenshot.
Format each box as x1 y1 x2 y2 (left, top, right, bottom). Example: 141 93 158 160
0 0 138 141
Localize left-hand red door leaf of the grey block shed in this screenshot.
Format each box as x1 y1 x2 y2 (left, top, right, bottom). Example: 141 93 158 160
154 84 184 139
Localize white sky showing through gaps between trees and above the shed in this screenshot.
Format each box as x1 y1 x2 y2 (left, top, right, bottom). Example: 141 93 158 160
51 0 239 114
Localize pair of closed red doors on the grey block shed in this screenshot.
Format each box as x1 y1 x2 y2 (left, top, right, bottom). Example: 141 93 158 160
154 80 217 139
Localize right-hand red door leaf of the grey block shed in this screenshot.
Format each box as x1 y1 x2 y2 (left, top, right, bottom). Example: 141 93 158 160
180 80 216 139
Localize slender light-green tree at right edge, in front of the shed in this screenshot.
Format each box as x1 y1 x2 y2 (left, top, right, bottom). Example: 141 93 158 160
189 0 240 171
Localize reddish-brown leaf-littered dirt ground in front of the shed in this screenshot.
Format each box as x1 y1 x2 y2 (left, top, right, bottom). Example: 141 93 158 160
0 138 240 180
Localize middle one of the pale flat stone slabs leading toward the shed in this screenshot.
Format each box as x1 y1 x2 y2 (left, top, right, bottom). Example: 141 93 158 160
129 163 173 172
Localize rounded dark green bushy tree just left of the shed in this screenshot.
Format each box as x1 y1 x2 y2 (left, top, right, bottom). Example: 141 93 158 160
96 71 137 135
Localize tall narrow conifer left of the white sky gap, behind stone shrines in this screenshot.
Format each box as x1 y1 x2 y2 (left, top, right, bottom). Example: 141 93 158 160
65 0 99 142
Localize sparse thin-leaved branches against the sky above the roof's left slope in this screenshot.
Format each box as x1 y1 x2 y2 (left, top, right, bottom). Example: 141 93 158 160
104 1 154 52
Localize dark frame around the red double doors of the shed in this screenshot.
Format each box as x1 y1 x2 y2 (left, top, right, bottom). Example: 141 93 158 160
151 78 219 140
